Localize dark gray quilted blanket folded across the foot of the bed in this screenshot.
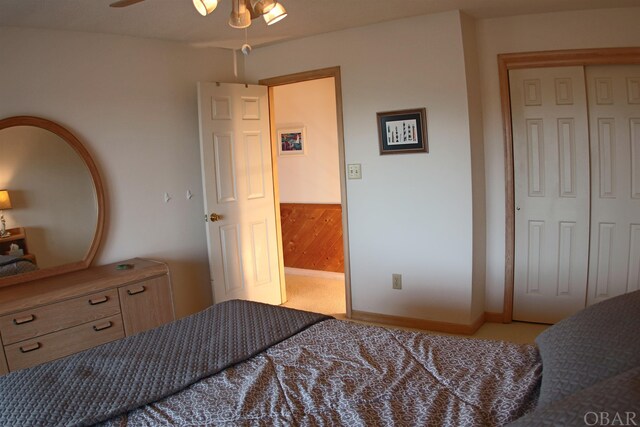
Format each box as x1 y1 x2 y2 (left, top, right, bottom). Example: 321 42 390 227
0 300 328 427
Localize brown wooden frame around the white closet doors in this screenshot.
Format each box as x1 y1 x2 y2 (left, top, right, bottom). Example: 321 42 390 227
498 48 640 323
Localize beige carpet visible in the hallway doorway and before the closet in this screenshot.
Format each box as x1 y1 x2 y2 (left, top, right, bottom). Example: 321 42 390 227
283 274 549 344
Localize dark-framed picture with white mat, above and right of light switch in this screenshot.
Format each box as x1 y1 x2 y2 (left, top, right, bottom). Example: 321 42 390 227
376 108 429 155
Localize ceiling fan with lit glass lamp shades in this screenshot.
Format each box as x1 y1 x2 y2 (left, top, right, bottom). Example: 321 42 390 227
109 0 287 28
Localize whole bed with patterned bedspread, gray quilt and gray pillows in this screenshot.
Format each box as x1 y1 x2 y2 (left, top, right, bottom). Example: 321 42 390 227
0 292 640 426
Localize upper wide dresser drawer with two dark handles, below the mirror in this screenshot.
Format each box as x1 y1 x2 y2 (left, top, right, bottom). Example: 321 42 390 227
0 289 120 346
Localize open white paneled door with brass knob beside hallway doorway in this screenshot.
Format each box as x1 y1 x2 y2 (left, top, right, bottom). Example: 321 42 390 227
198 83 282 304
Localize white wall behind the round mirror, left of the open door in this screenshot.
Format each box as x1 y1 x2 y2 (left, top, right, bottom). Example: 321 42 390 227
0 27 235 316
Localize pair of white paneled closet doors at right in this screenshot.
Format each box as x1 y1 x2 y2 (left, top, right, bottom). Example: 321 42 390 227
509 65 640 323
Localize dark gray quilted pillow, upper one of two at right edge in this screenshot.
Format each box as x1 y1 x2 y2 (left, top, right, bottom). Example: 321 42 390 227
536 291 640 407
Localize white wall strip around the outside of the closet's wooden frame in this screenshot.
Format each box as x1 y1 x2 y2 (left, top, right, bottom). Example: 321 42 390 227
477 8 640 312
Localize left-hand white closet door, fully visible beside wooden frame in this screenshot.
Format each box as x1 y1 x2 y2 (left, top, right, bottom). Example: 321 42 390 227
509 67 590 323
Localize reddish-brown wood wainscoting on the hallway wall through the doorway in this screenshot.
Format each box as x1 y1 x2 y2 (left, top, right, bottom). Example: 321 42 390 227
280 203 344 273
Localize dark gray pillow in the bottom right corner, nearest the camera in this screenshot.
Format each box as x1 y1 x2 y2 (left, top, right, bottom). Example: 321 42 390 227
509 367 640 427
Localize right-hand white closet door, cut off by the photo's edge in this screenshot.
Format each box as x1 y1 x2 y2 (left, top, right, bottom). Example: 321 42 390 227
586 65 640 304
